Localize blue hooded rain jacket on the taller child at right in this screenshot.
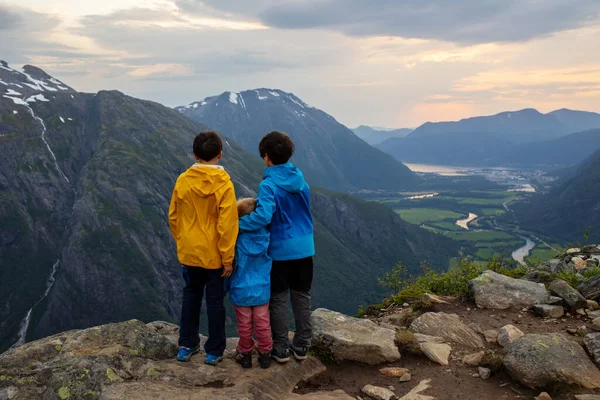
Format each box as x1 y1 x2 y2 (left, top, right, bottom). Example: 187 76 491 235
240 162 315 261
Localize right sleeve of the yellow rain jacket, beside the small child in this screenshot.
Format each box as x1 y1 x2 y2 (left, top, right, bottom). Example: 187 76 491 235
217 181 238 267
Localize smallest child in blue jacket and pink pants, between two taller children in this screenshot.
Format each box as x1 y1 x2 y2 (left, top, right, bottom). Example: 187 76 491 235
229 198 273 368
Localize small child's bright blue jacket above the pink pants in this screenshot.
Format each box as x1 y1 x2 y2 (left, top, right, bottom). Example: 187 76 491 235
229 228 272 307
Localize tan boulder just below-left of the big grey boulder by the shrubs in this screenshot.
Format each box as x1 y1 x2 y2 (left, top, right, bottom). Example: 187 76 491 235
410 312 483 348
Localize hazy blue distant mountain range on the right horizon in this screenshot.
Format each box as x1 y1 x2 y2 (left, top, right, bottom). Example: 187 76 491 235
376 109 600 166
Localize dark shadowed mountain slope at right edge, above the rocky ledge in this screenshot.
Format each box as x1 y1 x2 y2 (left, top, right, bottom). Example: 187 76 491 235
514 150 600 242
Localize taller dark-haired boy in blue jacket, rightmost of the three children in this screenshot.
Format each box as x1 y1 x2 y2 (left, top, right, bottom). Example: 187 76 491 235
240 131 315 363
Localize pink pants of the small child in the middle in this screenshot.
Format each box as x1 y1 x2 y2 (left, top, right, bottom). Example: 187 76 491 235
235 303 273 353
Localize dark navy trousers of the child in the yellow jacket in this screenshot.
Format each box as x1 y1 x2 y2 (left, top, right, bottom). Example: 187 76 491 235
179 266 225 356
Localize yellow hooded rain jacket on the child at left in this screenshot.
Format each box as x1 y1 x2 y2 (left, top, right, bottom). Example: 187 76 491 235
169 163 238 269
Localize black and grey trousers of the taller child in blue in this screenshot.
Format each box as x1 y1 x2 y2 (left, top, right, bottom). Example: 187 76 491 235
269 257 313 350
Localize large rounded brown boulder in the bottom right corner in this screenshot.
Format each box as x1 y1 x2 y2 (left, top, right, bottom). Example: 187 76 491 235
504 334 600 389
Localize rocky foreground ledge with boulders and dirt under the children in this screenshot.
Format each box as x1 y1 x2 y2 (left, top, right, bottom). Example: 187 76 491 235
0 247 600 400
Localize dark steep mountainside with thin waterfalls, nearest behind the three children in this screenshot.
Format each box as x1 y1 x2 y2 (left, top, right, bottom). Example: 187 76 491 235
0 63 456 351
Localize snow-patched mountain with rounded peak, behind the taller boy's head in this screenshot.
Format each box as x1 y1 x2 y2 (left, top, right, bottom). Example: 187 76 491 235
177 89 419 191
